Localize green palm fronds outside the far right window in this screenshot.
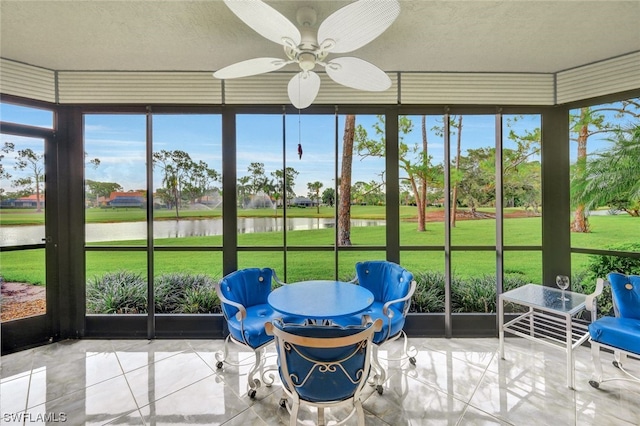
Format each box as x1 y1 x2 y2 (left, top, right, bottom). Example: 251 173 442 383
572 125 640 217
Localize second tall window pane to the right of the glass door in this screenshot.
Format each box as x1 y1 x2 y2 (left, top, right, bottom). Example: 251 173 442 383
152 114 223 314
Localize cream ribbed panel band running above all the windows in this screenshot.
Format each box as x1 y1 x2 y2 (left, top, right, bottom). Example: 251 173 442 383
0 58 640 105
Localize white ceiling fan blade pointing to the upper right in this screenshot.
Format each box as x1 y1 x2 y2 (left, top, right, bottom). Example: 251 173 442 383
318 0 400 53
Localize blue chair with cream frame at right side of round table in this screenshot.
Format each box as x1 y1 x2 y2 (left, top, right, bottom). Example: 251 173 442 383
354 260 418 394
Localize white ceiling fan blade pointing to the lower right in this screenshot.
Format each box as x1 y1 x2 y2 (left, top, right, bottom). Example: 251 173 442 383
326 57 391 92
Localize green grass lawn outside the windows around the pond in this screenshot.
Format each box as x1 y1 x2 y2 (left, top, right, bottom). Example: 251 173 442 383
0 210 640 284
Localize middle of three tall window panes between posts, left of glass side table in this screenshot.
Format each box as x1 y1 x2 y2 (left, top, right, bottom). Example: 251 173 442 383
443 114 496 313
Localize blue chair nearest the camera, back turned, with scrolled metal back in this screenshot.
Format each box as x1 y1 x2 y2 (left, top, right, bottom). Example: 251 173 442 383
265 319 382 426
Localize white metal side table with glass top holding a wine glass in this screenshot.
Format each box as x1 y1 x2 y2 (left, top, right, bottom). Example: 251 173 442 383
498 284 602 389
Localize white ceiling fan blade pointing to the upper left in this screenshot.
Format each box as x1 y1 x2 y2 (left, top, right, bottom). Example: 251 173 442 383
224 0 301 46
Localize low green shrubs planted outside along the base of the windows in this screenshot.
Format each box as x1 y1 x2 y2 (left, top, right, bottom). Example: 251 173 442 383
87 262 640 315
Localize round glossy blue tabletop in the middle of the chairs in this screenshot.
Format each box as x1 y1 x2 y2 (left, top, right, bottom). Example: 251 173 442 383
268 280 373 320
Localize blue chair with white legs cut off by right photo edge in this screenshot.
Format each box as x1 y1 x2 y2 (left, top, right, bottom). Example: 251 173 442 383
589 272 640 388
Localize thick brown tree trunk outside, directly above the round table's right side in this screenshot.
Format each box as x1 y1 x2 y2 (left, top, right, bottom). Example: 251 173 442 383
338 115 356 246
